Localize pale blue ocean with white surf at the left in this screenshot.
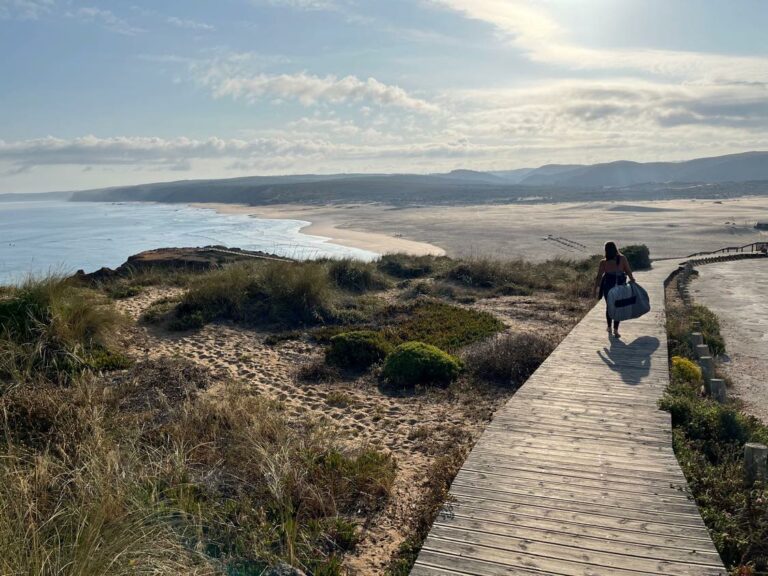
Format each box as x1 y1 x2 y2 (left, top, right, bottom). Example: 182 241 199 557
0 201 377 284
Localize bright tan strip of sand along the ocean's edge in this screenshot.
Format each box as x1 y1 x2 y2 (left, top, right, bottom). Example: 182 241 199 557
189 202 446 256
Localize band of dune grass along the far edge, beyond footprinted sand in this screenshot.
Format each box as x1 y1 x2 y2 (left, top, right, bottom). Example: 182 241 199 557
160 254 597 332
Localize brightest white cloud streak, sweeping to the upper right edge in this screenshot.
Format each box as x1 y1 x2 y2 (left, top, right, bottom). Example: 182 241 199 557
432 0 768 83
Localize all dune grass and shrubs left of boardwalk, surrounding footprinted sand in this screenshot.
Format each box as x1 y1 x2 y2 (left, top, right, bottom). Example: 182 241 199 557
0 255 594 576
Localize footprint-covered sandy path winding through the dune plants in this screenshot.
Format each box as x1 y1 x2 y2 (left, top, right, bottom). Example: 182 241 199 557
111 288 528 575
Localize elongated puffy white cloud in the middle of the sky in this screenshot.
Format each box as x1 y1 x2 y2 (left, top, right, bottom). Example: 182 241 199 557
203 71 439 113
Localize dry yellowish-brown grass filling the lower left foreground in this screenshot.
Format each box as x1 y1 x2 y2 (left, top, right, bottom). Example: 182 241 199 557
0 360 395 575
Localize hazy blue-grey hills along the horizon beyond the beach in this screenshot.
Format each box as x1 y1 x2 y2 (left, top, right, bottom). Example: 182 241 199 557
64 152 768 206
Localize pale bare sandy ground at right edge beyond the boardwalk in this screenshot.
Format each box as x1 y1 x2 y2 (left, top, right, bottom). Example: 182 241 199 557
691 260 768 422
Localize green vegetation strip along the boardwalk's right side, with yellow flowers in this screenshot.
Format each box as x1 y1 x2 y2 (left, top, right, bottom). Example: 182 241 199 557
660 268 768 576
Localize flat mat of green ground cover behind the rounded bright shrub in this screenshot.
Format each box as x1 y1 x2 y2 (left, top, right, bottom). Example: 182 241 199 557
389 301 504 351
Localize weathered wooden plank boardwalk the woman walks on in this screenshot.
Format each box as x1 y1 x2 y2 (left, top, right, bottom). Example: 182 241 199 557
411 265 726 576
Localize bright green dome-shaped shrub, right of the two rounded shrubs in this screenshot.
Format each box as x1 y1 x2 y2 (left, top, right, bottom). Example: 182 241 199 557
382 342 461 386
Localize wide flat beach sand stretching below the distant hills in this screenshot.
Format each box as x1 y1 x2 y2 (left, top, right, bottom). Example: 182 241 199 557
193 197 768 260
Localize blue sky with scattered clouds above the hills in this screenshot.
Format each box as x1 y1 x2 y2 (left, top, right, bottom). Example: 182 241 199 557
0 0 768 193
